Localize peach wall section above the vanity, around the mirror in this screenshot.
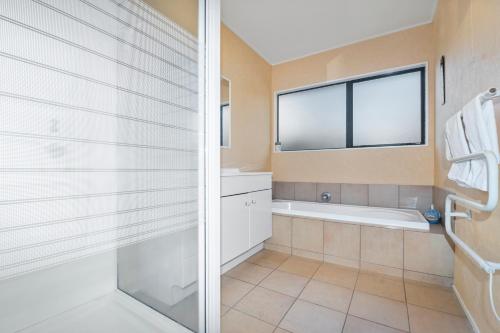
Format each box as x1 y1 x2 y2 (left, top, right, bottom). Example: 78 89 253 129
221 25 271 171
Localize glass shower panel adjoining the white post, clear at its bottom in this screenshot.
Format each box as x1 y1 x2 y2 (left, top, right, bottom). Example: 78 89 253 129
116 1 199 331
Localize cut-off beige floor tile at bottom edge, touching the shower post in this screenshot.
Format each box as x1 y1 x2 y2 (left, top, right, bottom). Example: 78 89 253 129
221 310 274 333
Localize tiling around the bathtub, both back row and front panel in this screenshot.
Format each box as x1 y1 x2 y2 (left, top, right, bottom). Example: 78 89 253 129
265 182 454 286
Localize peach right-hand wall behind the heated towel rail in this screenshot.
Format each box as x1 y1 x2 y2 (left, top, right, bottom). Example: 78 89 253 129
434 0 500 333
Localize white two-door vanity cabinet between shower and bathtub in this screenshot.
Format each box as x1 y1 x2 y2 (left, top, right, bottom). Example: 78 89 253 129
221 172 272 264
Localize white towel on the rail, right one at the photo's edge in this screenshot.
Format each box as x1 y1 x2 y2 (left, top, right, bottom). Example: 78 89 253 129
462 96 500 191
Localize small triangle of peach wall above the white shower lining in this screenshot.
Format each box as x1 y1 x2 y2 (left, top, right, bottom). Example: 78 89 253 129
144 0 198 36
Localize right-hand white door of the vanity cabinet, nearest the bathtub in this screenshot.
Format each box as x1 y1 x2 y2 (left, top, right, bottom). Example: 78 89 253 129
249 190 273 247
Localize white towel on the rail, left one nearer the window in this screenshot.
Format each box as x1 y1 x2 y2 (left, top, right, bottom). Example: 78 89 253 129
445 111 471 187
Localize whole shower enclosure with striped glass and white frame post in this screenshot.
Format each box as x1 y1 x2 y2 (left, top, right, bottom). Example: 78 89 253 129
0 0 219 332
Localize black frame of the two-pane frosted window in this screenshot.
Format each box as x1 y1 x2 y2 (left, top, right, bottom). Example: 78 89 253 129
276 65 427 152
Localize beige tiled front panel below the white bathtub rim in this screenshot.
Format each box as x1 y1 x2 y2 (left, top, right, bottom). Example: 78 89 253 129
265 215 454 286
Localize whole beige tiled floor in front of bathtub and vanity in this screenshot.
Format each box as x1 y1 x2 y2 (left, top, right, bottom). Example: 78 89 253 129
221 250 472 333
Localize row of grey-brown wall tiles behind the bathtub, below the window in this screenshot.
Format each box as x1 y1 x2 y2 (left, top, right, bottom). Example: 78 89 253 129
273 181 433 212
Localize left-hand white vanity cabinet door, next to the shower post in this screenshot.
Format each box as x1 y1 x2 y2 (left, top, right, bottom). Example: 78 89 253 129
221 194 250 264
